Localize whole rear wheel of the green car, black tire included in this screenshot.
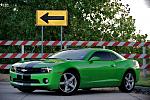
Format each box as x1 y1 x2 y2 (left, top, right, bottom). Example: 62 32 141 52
119 71 135 93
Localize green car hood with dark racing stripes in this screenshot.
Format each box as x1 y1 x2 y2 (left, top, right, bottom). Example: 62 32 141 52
12 59 66 68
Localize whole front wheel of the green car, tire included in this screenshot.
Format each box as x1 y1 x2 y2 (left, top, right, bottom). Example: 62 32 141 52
59 72 79 95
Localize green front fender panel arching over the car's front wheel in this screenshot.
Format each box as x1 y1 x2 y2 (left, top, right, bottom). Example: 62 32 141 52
53 60 92 87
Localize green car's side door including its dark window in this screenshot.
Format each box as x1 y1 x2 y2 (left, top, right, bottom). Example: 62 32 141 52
85 51 118 87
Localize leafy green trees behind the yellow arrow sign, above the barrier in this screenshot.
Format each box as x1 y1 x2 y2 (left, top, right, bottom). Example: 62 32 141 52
0 0 146 41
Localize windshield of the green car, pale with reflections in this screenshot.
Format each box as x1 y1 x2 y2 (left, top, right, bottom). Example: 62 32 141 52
49 50 87 60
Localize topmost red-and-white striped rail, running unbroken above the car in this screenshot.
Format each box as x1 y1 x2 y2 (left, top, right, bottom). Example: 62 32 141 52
0 40 150 47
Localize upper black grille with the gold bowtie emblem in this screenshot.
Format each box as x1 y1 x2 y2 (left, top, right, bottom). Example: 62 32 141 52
16 67 42 74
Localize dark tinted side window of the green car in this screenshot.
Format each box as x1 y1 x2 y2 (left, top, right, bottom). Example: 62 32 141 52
92 51 119 61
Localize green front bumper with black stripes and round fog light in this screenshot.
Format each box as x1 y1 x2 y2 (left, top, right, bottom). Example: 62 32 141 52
10 71 60 90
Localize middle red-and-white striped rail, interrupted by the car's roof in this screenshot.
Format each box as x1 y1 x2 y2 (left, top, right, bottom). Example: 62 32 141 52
0 53 150 58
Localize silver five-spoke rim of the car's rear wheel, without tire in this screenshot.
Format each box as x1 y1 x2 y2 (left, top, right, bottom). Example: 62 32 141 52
125 73 134 90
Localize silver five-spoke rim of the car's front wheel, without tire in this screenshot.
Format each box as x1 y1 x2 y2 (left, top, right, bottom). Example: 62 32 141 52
60 73 77 93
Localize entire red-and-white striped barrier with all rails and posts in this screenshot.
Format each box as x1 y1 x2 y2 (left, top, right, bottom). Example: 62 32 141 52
0 40 150 69
